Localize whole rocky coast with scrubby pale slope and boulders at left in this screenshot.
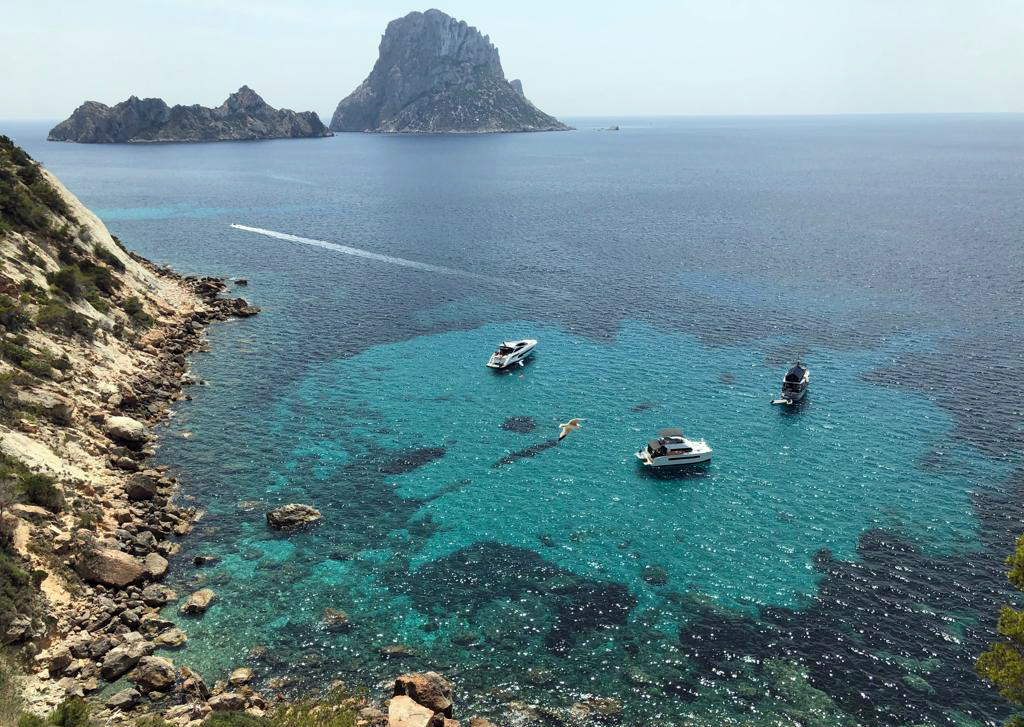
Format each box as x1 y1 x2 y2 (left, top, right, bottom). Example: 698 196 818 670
0 137 505 727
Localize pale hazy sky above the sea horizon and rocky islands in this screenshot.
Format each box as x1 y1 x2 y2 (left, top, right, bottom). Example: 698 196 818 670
0 0 1024 121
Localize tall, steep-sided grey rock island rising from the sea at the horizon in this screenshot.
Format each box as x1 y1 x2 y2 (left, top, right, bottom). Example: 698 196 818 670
331 10 569 133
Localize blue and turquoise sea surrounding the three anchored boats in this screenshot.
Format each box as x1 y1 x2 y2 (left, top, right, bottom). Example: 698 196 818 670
0 116 1024 725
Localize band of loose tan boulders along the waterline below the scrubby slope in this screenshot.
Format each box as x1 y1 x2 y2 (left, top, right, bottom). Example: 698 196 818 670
8 264 503 727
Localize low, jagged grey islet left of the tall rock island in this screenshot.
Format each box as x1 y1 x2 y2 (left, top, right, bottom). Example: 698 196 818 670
47 86 331 143
